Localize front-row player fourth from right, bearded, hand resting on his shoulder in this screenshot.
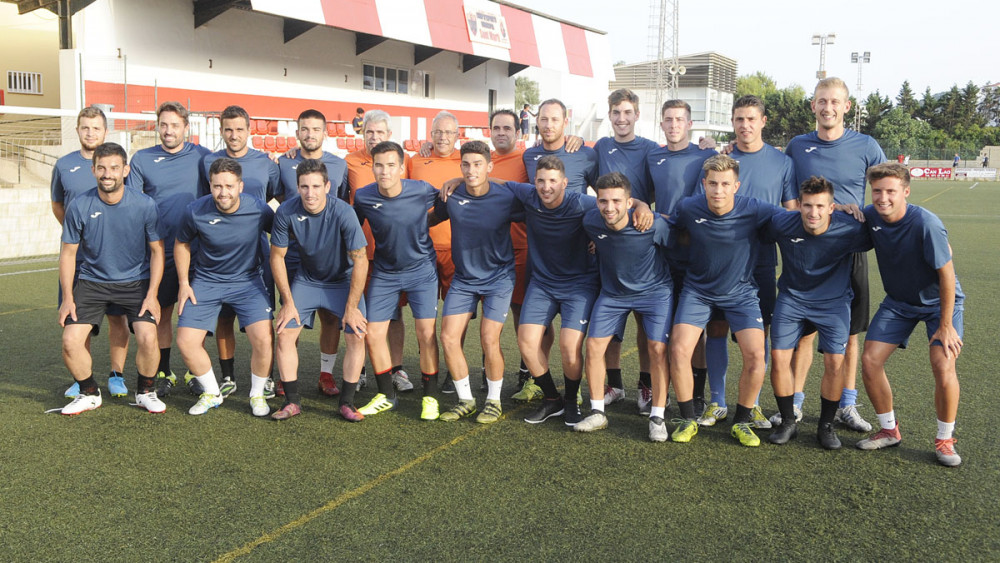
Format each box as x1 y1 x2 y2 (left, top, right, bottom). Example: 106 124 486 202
574 172 673 442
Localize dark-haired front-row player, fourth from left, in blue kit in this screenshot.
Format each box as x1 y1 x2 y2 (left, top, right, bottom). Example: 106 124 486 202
354 141 440 420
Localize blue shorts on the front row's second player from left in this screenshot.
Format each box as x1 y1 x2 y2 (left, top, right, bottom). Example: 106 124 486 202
177 278 274 334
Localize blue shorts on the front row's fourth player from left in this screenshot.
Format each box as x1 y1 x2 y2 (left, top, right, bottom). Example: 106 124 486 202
365 260 438 323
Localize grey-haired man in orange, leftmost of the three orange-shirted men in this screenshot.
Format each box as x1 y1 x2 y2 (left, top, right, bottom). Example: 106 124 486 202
344 109 413 391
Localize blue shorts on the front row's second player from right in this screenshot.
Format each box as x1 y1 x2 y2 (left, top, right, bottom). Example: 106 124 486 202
771 293 851 354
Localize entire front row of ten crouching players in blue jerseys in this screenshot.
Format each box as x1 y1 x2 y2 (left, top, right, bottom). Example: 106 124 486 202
59 142 964 466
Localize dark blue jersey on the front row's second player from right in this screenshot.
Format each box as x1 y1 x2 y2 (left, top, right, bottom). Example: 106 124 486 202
764 210 872 305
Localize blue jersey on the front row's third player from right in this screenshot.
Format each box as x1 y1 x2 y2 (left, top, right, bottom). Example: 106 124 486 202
670 196 779 298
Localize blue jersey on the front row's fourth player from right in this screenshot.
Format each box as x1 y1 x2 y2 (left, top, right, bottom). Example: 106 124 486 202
583 207 670 297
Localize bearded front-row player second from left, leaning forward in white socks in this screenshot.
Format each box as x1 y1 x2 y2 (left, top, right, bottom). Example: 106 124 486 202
174 157 274 416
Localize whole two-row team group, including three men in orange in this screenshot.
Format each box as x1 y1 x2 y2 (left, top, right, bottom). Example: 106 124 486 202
52 79 963 465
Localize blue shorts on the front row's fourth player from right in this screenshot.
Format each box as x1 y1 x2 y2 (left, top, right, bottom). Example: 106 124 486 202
590 286 673 343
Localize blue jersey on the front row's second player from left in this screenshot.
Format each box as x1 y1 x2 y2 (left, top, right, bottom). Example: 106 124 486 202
177 192 274 282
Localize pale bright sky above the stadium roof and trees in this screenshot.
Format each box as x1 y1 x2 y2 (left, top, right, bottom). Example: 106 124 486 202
514 0 1000 99
